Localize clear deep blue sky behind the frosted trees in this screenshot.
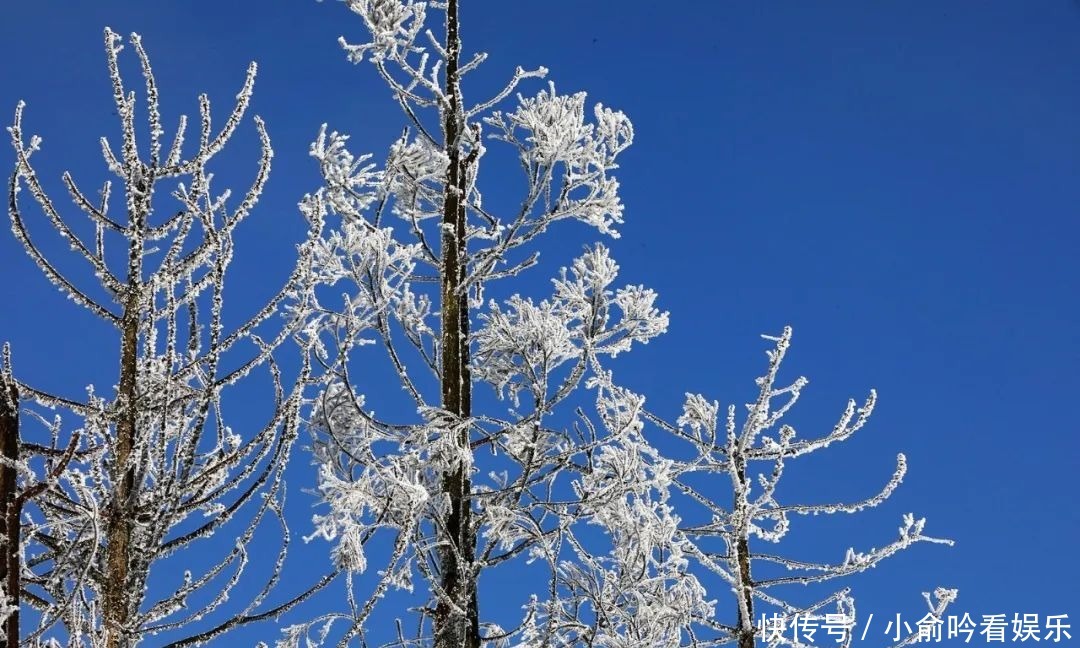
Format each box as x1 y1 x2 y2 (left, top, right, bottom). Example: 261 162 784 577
0 0 1080 645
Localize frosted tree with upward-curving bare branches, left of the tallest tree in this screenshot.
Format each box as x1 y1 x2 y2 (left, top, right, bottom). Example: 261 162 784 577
5 28 324 648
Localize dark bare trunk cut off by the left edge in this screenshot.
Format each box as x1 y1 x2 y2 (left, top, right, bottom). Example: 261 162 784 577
0 367 23 648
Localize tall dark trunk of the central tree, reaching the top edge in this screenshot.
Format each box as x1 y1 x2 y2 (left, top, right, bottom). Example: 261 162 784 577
434 0 480 648
